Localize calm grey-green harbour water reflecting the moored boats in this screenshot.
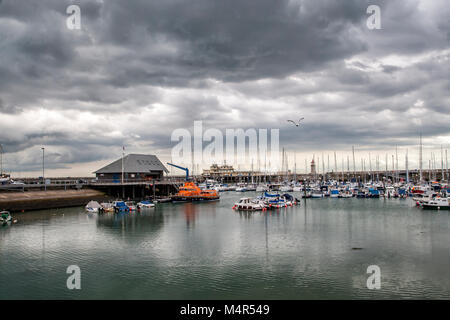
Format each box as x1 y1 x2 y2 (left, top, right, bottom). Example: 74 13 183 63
0 192 450 299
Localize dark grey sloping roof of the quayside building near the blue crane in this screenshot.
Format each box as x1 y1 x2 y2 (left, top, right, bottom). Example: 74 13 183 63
94 154 169 173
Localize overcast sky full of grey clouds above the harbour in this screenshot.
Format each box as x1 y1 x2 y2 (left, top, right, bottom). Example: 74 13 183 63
0 0 450 177
